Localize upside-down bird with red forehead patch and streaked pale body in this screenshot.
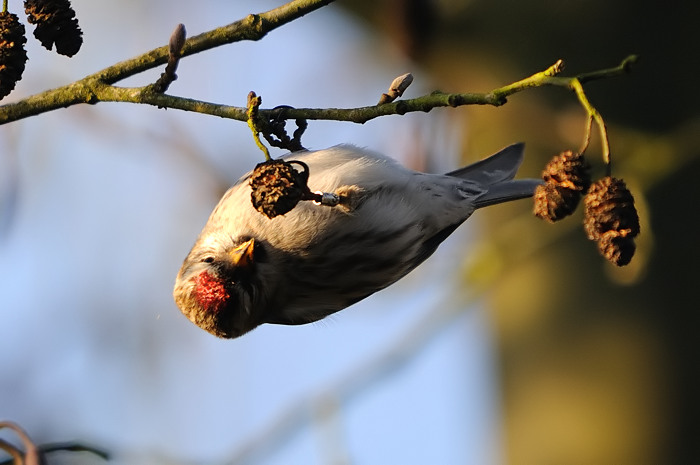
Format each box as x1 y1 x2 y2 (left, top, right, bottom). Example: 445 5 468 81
173 143 541 339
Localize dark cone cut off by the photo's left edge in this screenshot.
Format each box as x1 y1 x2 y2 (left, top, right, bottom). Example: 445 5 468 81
0 11 27 99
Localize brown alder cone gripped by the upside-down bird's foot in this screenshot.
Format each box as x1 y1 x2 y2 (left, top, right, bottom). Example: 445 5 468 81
250 160 309 218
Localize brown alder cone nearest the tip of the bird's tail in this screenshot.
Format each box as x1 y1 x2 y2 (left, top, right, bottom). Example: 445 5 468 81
534 150 591 223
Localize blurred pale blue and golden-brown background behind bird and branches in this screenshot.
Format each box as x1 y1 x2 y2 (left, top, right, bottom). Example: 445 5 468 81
0 0 700 465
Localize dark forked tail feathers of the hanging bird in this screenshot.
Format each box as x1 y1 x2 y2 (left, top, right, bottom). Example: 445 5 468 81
447 142 542 208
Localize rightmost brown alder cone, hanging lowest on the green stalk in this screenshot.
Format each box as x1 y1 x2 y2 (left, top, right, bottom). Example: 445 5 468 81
583 176 639 266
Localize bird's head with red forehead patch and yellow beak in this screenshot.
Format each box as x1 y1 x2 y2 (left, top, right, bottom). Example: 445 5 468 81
173 235 265 338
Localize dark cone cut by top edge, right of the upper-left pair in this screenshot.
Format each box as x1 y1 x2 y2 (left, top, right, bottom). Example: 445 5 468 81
24 0 83 57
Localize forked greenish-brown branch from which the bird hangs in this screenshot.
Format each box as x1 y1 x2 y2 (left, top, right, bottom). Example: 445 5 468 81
0 0 636 146
